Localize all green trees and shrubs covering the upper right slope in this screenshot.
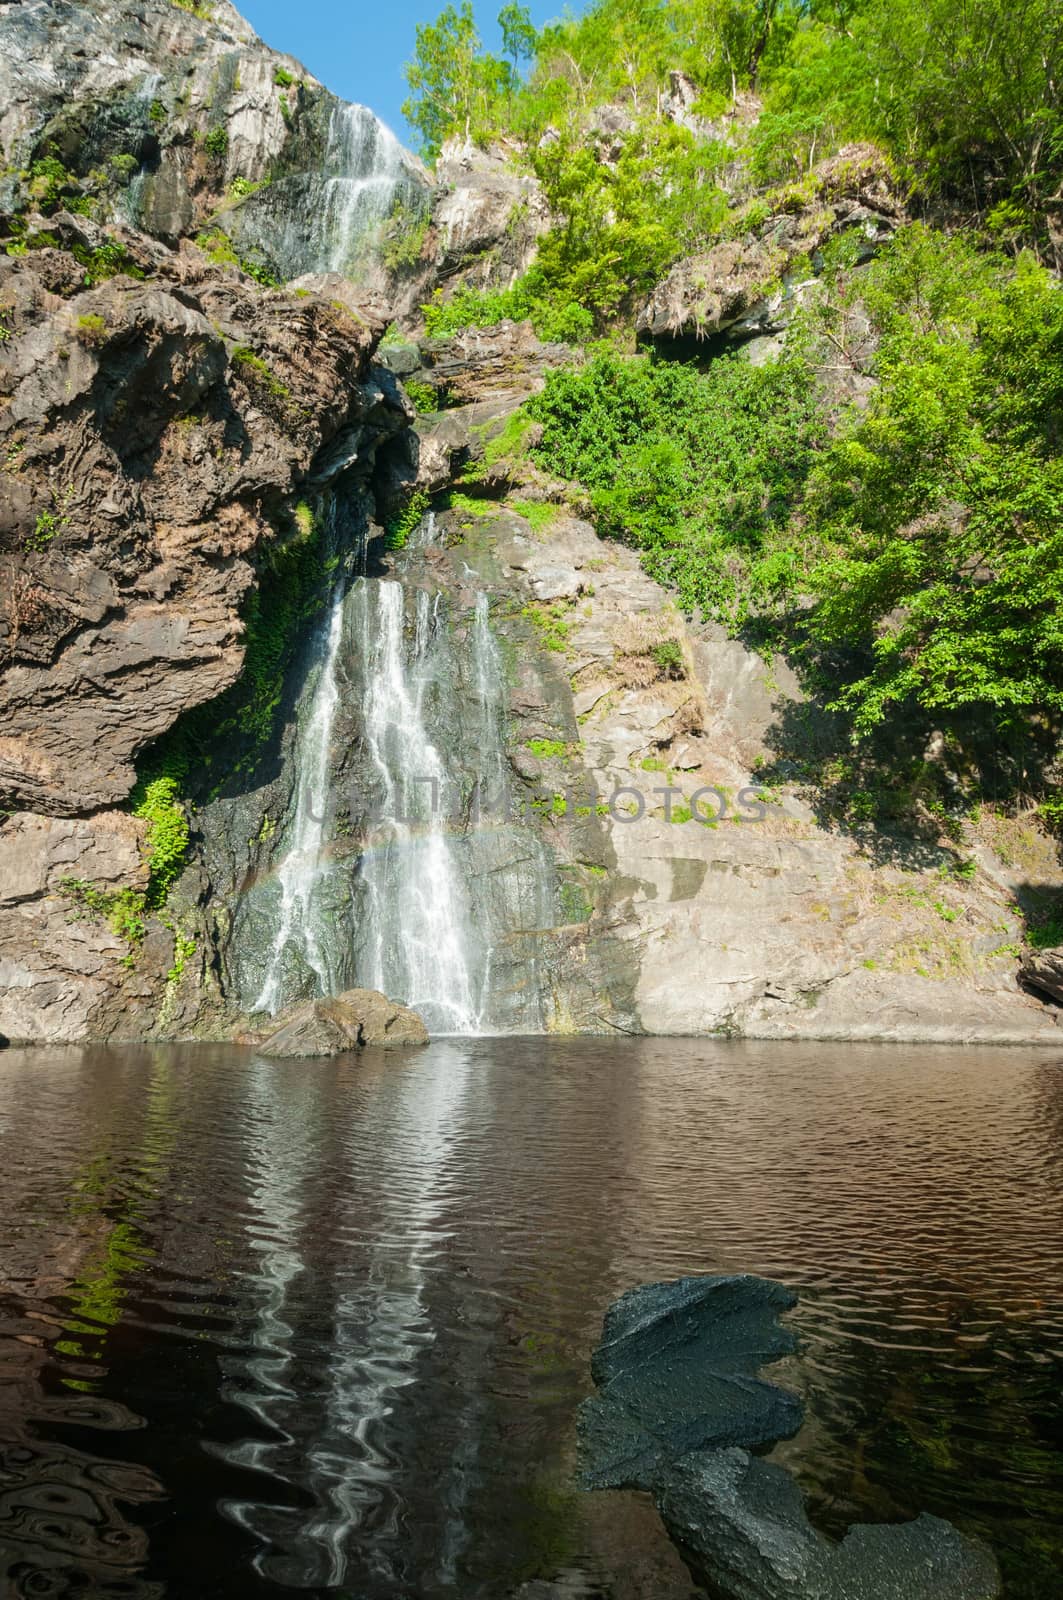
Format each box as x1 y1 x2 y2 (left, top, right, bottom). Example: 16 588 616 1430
407 0 1063 814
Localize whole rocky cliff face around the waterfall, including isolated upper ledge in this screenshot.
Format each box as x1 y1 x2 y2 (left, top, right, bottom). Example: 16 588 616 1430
0 0 1060 1040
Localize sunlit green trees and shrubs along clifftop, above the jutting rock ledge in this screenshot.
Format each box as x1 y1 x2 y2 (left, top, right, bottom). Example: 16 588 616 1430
405 0 1063 333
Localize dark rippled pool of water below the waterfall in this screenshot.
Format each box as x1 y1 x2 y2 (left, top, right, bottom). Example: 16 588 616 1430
0 1038 1063 1600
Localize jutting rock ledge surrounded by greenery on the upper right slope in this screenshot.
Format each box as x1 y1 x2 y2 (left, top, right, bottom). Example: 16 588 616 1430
636 146 905 350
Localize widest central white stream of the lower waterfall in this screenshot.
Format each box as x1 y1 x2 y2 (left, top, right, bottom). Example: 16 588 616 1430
355 581 482 1034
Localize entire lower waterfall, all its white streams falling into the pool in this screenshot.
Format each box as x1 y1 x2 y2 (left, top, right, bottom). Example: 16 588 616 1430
242 514 525 1034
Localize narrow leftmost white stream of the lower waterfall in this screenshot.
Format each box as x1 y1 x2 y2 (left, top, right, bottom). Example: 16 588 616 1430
251 582 346 1011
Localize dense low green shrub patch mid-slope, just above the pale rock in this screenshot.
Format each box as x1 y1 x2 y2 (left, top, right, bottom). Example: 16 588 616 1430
527 354 826 620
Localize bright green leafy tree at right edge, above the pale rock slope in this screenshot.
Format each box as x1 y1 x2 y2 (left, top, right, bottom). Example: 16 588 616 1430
807 227 1063 731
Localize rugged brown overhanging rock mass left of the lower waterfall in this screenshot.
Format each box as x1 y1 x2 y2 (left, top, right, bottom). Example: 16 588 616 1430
0 232 405 816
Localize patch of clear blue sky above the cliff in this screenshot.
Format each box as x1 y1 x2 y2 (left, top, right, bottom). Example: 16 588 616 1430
235 0 560 144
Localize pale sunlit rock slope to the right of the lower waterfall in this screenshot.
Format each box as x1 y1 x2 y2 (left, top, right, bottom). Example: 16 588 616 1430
434 502 1061 1046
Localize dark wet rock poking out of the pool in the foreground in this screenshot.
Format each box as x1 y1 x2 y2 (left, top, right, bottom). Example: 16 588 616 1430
580 1277 1001 1600
